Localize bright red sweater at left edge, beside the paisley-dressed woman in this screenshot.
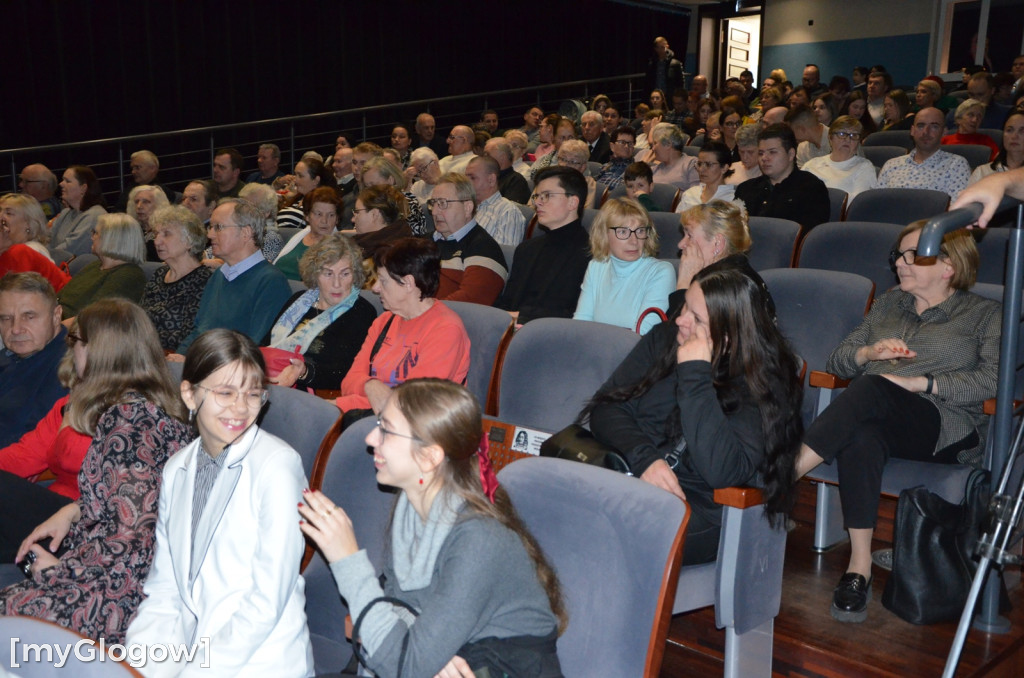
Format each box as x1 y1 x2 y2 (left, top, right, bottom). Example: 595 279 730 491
0 395 92 501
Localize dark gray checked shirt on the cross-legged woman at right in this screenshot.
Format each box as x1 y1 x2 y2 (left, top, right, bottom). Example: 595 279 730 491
825 290 1002 451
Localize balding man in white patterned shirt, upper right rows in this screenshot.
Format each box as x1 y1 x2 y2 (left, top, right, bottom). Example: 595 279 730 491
879 109 971 199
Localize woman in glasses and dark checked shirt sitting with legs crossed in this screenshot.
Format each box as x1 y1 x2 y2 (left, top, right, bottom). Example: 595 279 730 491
795 222 1001 622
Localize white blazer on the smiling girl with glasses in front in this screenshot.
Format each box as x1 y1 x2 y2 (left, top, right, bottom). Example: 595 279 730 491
126 425 313 678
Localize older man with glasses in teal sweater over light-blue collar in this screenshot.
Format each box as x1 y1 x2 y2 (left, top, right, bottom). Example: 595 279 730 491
172 200 292 352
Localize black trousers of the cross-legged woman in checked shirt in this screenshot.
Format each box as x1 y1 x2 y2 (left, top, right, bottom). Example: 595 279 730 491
804 375 977 529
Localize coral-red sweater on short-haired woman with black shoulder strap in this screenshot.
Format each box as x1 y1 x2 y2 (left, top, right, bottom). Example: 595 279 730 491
337 301 469 412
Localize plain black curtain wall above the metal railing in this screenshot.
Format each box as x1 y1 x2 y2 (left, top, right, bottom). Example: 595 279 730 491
0 0 689 147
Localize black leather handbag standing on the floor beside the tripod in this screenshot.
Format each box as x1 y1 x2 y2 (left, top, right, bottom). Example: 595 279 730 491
882 470 989 624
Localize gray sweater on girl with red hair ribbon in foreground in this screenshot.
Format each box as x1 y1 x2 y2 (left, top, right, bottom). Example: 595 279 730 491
331 497 556 678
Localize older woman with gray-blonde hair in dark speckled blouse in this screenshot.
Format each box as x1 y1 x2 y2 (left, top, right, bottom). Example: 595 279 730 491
139 204 214 351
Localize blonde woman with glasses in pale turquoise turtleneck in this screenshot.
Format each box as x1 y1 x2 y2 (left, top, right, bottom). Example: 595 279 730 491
572 198 675 334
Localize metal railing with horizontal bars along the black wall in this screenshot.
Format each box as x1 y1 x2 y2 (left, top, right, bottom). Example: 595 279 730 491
0 73 644 204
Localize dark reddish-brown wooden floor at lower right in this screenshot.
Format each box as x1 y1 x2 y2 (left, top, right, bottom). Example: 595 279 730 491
660 483 1024 678
